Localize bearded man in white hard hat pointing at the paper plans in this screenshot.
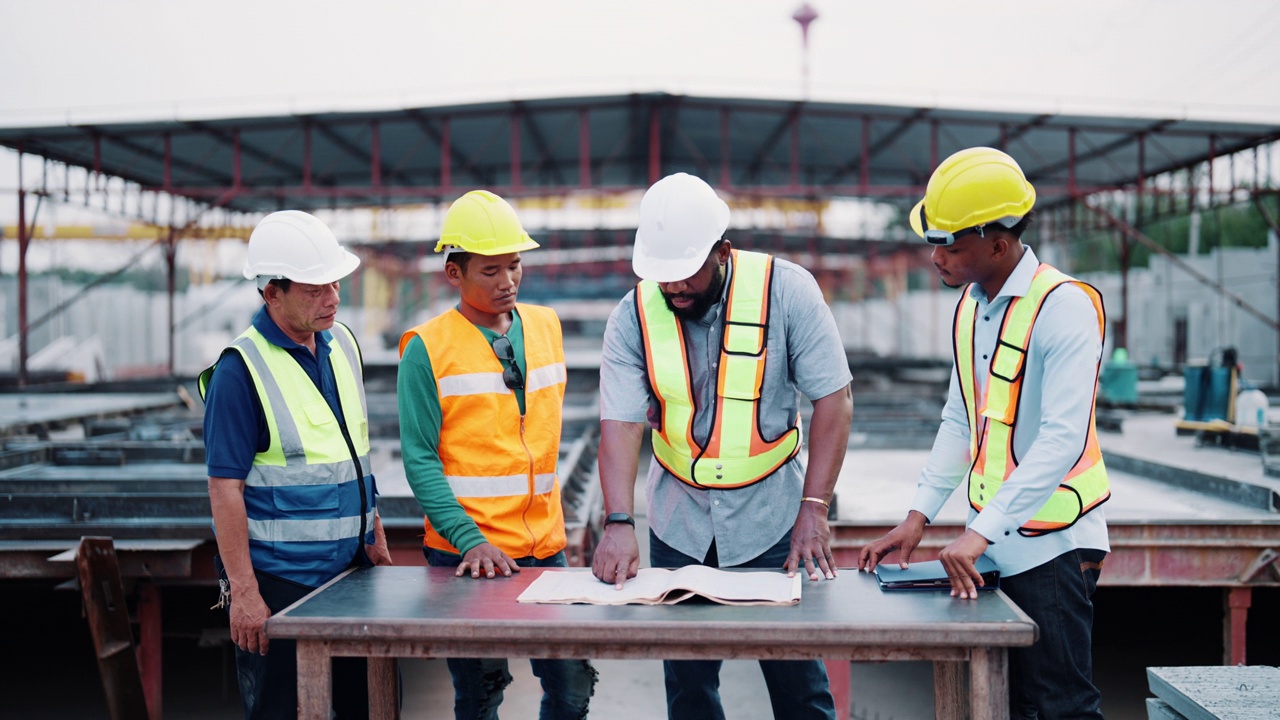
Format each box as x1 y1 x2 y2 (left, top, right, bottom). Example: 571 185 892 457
591 173 852 720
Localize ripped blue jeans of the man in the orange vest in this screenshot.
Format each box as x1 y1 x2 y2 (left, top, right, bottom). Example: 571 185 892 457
422 547 596 720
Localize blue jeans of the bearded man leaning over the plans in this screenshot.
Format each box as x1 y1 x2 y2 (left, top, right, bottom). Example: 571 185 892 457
649 530 836 720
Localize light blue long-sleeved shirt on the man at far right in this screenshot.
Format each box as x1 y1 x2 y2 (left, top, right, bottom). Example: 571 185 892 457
911 247 1111 575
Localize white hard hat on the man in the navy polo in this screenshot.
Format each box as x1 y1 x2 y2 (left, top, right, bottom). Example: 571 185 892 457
244 210 360 284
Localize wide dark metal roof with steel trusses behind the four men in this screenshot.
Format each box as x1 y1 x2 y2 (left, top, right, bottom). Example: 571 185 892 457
0 94 1280 213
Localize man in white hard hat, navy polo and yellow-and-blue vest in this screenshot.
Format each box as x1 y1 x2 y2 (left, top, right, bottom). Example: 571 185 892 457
200 210 392 720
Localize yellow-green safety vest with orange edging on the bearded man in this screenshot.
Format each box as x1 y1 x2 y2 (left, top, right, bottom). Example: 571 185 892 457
636 250 800 489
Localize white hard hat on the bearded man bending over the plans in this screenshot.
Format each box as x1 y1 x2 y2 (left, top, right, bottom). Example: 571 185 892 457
631 173 728 282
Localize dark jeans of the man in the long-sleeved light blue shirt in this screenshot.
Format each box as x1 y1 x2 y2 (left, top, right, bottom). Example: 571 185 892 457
1000 550 1106 720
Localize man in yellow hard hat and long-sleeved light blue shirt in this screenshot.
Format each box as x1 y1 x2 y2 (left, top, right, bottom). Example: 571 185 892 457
859 147 1111 719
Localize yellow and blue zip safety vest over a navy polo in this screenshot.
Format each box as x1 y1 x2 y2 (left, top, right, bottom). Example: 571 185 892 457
201 323 375 587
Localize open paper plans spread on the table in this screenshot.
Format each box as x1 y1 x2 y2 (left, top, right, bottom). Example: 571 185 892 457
517 565 801 605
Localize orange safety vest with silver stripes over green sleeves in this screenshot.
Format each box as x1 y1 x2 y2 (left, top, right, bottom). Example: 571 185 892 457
401 304 567 559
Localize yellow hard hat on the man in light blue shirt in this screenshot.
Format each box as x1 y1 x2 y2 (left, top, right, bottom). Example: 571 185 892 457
910 147 1036 245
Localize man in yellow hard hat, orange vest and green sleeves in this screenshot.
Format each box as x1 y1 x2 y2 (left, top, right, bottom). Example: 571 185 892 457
396 190 596 720
